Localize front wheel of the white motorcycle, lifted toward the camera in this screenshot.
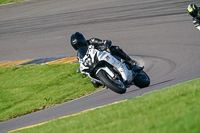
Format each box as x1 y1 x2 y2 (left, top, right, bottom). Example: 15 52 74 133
97 70 126 94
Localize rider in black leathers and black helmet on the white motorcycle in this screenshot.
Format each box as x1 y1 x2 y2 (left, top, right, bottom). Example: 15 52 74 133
71 32 136 67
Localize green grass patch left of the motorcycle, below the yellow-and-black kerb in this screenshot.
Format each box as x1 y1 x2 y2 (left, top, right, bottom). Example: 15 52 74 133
0 64 100 121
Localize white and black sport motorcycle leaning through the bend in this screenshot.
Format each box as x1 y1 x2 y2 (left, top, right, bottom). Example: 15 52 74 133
77 45 150 94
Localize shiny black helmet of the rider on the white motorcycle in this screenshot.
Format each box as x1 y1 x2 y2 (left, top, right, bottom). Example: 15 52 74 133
71 32 87 50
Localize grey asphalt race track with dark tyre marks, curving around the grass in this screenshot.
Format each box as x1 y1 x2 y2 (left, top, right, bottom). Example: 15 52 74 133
0 0 200 132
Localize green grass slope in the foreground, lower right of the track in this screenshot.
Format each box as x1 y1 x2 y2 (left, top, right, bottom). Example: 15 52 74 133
13 79 200 133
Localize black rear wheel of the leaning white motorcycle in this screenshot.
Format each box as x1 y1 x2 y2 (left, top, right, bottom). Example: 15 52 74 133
134 71 150 88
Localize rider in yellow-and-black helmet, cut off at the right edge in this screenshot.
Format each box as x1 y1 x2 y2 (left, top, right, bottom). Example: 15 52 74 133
187 4 200 30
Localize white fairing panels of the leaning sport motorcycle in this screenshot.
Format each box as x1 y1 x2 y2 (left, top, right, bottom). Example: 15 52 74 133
79 45 133 82
